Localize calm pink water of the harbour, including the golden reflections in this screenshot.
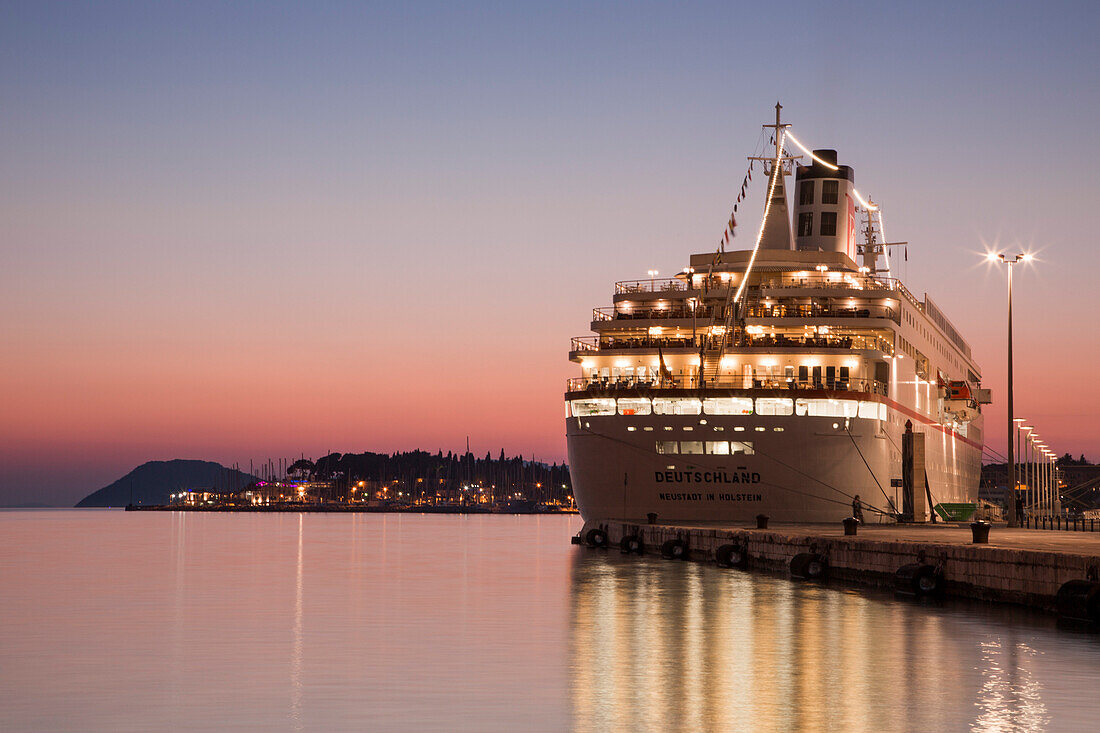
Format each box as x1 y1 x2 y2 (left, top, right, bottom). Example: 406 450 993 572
0 510 1100 731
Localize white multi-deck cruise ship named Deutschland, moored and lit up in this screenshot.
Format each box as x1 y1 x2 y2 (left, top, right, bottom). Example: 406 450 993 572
565 105 989 523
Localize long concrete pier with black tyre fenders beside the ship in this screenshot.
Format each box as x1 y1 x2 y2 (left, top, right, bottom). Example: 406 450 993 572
579 521 1100 610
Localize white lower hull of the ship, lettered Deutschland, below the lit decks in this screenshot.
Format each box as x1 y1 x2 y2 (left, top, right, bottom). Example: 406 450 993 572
567 405 981 522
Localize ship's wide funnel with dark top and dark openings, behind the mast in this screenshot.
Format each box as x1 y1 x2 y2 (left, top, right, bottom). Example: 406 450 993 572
794 150 858 260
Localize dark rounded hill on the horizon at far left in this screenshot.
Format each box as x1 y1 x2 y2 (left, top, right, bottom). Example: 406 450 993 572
76 459 256 507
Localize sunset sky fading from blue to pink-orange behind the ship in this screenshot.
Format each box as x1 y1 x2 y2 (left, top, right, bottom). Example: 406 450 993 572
0 2 1100 503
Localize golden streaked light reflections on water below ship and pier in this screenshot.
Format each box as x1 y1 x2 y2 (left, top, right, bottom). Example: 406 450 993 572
570 550 1100 731
